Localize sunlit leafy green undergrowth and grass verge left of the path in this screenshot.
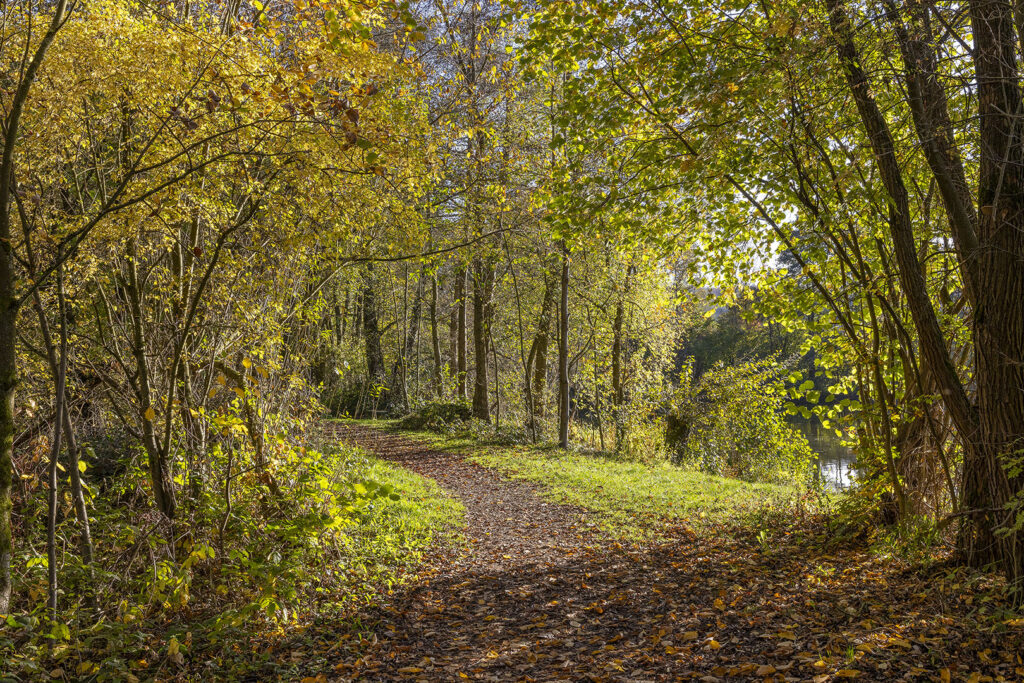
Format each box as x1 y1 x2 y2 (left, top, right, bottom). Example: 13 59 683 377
0 443 464 681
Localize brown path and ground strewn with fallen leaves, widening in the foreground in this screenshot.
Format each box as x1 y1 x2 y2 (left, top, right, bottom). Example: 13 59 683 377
266 425 1024 683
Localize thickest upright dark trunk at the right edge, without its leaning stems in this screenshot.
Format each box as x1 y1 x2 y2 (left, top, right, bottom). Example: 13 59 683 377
965 0 1024 589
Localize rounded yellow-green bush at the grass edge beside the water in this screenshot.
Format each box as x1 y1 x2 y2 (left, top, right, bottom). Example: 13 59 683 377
666 359 814 482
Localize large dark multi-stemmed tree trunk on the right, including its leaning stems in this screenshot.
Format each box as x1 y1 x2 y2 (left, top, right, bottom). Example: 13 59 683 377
826 0 1024 599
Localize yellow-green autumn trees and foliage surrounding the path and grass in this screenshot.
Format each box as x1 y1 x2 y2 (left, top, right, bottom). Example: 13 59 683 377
0 0 1024 680
